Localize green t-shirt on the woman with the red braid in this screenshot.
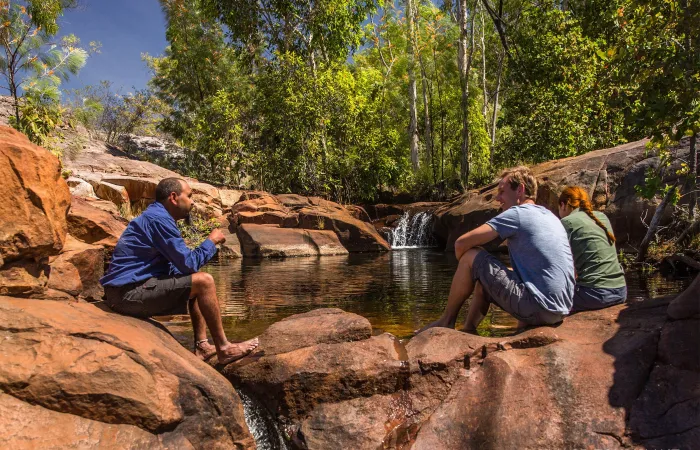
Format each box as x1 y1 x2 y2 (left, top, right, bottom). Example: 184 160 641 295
561 209 625 288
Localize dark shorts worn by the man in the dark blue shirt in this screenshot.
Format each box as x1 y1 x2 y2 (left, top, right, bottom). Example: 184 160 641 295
104 275 192 318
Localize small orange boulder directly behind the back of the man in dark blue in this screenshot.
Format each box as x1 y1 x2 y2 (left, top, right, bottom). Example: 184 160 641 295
48 235 105 300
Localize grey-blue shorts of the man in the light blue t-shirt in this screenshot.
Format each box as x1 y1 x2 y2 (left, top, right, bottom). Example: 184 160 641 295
472 250 564 325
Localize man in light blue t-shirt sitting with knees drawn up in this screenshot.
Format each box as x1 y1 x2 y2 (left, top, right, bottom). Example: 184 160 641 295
419 167 574 334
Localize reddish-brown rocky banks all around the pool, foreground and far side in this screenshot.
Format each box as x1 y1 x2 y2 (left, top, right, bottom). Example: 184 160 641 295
0 127 700 449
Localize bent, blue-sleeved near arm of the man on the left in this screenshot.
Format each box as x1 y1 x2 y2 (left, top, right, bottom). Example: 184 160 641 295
150 222 216 275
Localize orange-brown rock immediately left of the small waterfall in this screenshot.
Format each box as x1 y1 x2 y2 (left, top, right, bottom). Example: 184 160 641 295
299 207 390 252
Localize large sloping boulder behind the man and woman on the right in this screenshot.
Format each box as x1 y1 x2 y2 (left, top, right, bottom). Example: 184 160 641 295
435 138 689 250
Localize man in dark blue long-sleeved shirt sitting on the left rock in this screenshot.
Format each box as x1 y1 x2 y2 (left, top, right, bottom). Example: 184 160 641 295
100 178 258 364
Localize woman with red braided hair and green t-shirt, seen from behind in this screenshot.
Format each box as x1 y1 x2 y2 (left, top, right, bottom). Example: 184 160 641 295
559 186 627 312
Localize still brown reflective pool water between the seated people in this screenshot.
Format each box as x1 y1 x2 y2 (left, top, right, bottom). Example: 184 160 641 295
164 249 688 346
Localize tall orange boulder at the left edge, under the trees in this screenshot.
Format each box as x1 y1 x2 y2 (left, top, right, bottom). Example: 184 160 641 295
0 126 70 263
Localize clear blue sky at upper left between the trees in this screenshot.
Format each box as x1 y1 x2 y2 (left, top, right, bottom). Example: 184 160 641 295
59 0 167 92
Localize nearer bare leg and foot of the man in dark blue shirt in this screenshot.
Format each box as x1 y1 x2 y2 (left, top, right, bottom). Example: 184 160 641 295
191 272 258 364
